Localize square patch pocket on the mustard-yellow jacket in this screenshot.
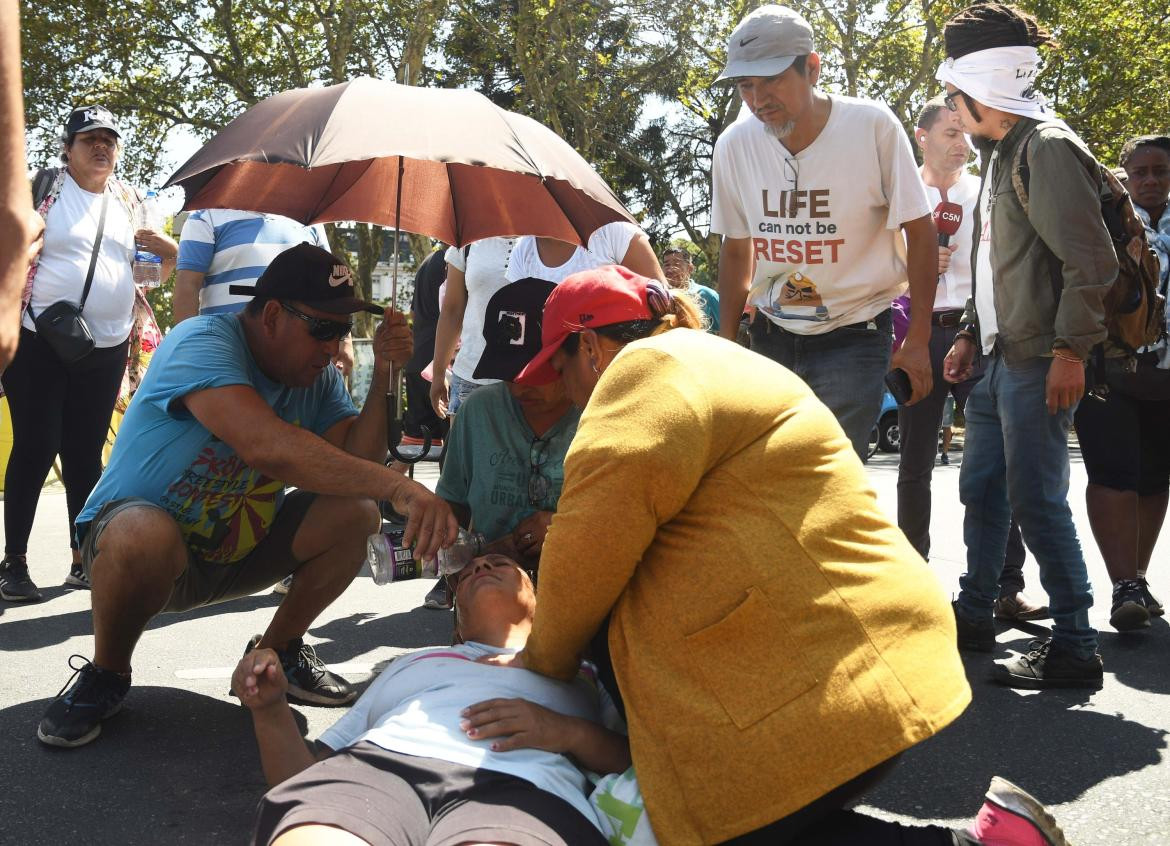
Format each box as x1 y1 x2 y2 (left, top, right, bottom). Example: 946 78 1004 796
684 587 817 729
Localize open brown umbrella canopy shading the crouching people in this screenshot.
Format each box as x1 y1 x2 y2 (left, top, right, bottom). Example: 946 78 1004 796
167 77 633 246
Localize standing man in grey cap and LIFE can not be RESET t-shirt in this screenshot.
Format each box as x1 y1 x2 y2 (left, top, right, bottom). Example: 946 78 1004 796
711 5 938 454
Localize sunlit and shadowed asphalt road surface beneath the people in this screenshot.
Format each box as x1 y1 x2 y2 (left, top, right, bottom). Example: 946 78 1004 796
0 449 1170 846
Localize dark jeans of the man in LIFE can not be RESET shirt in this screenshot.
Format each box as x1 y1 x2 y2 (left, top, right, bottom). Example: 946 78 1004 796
751 309 894 456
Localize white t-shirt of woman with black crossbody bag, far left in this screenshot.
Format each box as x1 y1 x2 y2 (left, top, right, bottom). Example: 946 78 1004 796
23 173 135 346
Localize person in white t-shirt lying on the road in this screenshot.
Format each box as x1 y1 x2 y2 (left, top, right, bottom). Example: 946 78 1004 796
233 555 631 846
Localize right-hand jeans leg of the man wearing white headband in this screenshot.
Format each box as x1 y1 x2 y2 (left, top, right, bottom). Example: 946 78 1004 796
998 358 1097 658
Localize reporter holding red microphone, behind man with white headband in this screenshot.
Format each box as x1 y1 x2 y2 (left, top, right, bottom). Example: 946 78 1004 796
897 96 983 558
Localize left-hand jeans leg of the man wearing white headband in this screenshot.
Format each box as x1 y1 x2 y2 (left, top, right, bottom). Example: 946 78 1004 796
958 355 1011 620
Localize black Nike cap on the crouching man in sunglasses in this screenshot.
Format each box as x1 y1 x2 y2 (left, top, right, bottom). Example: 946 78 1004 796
228 241 384 317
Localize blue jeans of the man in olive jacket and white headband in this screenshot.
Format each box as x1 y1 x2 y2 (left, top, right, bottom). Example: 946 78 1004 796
958 351 1097 658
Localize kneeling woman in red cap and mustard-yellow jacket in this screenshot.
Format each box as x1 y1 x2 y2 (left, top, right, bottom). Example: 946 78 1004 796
482 267 1051 845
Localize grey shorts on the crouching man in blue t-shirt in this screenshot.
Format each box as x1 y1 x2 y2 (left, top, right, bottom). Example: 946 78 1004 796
77 490 317 611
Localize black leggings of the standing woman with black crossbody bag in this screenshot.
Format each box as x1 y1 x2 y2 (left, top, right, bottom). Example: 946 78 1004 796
0 329 129 555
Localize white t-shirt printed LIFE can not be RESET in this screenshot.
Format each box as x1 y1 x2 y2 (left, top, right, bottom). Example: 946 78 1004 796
711 95 932 335
